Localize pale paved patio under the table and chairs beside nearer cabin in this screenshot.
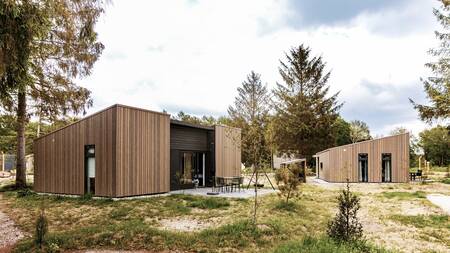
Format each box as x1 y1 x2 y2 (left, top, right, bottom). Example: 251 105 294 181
169 187 277 199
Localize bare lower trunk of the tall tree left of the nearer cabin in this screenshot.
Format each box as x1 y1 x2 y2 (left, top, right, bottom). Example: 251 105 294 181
16 91 27 188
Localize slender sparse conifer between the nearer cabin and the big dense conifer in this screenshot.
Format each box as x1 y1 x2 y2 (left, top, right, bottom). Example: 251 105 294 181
228 71 270 166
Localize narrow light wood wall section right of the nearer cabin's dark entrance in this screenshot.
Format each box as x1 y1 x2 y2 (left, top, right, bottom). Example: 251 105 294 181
215 126 241 177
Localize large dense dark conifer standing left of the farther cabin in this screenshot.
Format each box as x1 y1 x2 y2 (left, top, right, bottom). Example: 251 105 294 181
274 45 342 156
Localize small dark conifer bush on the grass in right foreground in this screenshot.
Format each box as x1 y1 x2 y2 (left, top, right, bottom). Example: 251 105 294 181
327 180 363 242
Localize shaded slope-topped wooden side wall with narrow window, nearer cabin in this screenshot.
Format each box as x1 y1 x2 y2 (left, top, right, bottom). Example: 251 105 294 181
34 106 116 196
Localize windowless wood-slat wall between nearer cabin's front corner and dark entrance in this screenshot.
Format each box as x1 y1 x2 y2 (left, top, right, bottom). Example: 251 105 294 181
115 106 170 197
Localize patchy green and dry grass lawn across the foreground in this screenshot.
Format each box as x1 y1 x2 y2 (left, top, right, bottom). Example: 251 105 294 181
0 179 450 253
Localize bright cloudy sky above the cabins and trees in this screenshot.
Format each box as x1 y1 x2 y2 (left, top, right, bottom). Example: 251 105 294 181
79 0 439 135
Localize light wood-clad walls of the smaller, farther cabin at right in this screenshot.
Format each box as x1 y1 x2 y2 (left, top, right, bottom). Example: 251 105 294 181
317 133 409 182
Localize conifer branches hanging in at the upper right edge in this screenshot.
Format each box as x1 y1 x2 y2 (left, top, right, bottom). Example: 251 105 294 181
410 0 450 123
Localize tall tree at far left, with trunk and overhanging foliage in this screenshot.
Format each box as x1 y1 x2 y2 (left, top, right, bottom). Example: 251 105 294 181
0 0 104 187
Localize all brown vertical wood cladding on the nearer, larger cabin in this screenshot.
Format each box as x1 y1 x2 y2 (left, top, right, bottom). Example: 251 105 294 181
34 105 241 197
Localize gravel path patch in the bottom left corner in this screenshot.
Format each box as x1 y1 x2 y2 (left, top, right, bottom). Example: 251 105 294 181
0 194 24 252
